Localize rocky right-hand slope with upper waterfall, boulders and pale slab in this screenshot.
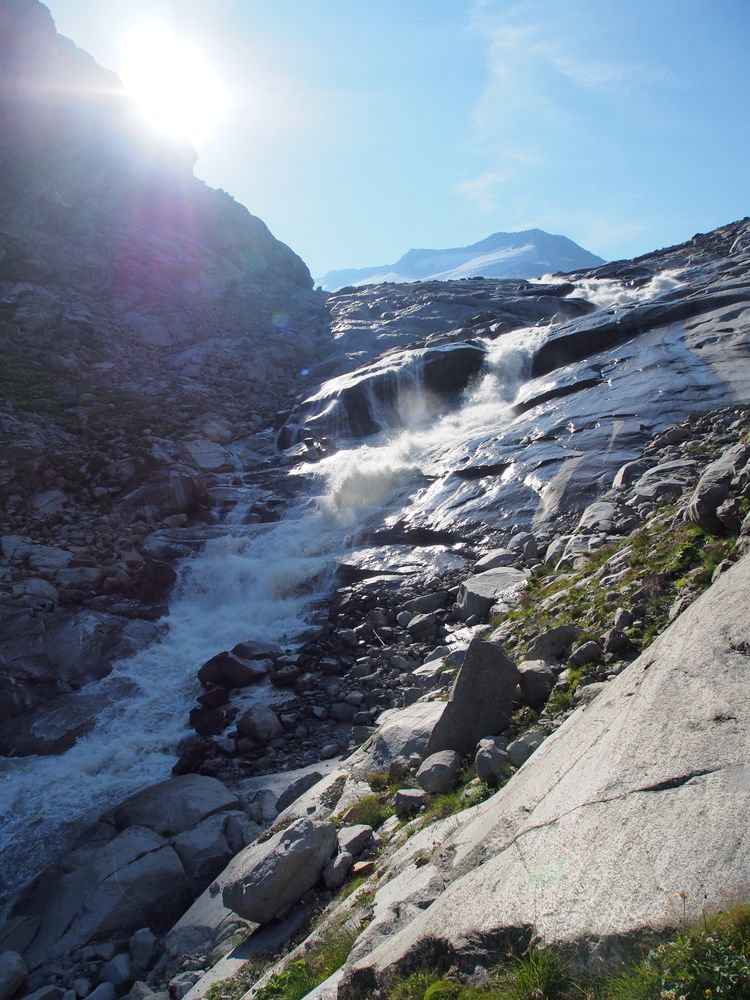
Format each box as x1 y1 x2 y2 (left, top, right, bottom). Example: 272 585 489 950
2 205 750 1000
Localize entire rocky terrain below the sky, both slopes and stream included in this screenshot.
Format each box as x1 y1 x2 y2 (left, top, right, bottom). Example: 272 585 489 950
0 0 750 1000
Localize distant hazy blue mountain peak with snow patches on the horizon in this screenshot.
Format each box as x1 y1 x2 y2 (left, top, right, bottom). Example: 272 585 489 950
320 229 604 291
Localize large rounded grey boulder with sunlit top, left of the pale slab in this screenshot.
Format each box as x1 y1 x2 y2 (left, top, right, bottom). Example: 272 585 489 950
222 819 336 924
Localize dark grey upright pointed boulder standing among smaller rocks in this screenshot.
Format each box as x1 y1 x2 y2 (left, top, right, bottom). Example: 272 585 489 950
424 638 520 757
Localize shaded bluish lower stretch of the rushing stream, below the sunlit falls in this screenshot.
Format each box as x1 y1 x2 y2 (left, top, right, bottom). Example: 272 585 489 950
0 502 362 884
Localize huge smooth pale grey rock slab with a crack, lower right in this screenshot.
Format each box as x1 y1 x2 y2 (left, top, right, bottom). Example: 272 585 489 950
340 557 750 997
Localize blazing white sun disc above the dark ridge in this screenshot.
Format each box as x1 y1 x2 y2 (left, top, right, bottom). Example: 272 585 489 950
122 25 229 143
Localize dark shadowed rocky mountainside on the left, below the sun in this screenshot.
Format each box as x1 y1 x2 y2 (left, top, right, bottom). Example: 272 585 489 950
0 0 327 753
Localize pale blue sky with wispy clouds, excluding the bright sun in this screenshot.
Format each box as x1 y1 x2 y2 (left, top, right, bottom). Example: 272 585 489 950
47 0 750 276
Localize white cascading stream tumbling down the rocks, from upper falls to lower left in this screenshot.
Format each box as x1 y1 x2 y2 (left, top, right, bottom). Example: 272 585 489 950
0 276 688 886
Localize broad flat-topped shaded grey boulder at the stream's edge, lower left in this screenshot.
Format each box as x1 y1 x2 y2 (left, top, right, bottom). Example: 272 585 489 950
114 774 240 836
